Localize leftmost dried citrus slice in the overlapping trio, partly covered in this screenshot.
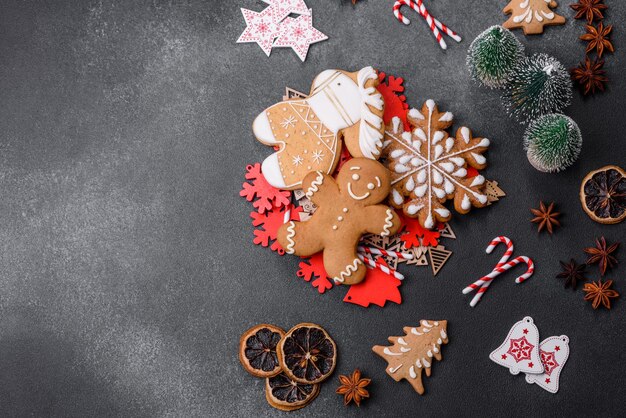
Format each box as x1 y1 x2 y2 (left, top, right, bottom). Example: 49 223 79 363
239 324 285 377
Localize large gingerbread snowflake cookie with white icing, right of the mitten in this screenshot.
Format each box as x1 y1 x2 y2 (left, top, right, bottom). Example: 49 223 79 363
383 100 489 229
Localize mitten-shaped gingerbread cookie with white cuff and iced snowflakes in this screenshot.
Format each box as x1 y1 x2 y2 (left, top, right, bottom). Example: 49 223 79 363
252 67 384 190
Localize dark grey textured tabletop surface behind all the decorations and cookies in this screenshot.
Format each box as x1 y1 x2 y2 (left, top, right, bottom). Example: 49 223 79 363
0 0 626 417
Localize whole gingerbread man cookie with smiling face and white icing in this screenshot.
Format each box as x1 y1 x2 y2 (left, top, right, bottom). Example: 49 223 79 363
278 158 400 284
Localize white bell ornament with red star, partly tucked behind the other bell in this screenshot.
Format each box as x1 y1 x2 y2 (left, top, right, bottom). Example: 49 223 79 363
526 335 569 393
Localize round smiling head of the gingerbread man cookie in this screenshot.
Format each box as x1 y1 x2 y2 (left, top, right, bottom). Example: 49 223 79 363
337 159 391 205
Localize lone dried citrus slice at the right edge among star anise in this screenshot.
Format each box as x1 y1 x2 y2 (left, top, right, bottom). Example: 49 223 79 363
580 165 626 224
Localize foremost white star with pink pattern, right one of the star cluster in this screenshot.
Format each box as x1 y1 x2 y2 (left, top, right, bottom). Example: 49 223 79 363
274 10 328 61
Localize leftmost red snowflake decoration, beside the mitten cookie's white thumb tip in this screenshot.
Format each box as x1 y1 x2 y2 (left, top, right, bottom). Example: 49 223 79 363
239 163 291 214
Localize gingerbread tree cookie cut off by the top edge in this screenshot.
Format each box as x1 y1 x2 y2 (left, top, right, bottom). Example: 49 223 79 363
502 0 565 35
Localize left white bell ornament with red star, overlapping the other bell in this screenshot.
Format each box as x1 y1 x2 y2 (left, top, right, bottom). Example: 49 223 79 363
489 316 543 374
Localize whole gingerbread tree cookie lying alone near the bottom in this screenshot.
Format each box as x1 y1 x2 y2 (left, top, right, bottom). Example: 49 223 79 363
372 320 448 395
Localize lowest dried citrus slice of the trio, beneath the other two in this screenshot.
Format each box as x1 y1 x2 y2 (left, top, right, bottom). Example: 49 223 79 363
265 373 320 411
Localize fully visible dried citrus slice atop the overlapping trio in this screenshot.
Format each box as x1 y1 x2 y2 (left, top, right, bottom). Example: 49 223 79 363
276 323 337 383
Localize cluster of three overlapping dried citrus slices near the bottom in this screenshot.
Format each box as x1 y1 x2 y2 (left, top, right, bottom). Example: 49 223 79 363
239 323 337 411
